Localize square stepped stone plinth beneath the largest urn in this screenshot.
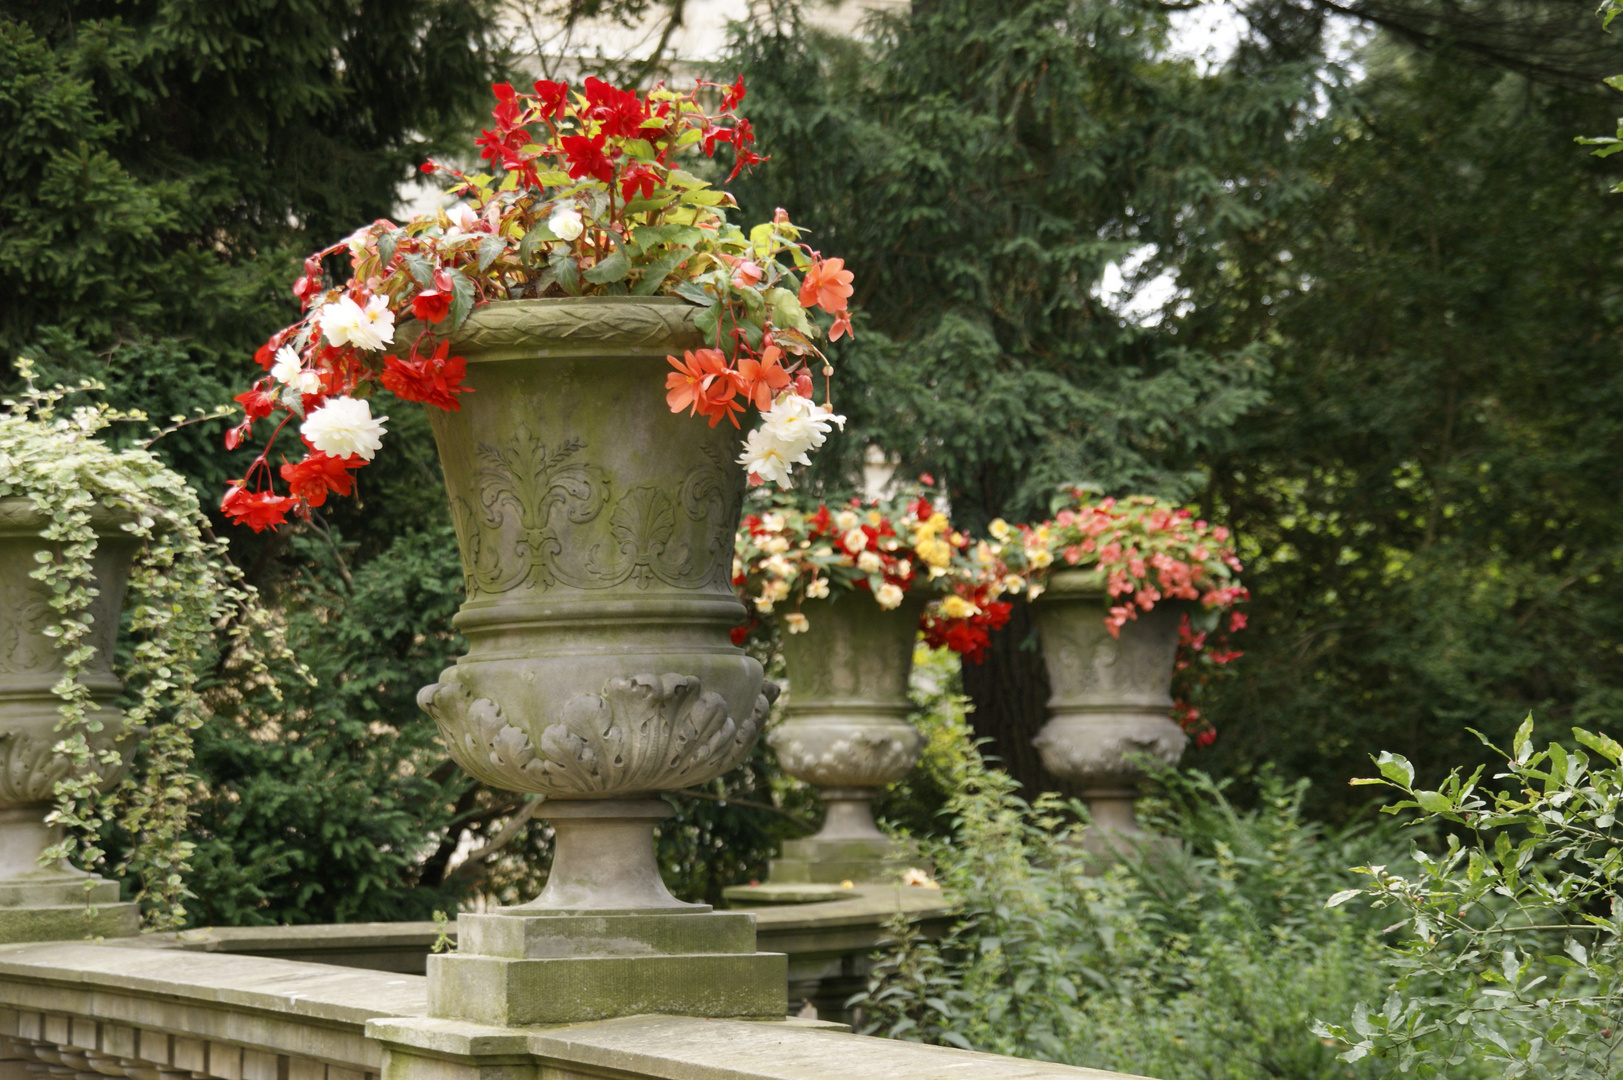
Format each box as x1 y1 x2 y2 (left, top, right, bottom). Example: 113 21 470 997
428 905 789 1026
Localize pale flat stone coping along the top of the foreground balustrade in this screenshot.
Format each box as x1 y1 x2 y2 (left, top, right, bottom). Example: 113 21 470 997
0 935 1149 1080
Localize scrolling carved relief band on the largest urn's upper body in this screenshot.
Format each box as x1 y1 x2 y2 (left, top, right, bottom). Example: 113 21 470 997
451 429 740 593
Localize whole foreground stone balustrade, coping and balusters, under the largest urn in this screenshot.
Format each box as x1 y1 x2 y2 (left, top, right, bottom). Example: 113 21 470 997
0 937 1126 1080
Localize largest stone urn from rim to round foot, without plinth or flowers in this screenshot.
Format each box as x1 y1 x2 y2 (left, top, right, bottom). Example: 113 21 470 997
417 297 777 911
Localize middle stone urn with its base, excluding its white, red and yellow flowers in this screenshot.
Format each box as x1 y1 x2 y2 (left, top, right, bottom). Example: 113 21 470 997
766 593 927 885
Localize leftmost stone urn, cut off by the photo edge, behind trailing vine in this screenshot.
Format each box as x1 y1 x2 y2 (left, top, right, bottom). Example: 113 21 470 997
0 499 140 942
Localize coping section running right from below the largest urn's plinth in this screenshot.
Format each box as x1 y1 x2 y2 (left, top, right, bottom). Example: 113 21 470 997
367 1017 1130 1080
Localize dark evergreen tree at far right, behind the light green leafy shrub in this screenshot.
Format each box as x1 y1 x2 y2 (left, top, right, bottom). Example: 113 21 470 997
1206 35 1623 814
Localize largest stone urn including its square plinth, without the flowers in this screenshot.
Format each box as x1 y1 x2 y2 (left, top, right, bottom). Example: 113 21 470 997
418 297 786 1025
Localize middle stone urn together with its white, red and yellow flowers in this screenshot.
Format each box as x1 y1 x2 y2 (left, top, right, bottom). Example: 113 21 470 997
735 495 974 887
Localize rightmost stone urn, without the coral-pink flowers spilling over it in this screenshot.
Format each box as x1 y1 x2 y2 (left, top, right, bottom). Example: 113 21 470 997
1032 570 1190 854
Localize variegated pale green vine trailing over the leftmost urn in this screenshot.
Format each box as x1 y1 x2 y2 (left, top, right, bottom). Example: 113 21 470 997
0 359 298 929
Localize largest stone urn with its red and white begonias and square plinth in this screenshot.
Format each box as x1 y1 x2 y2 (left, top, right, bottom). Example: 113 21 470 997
222 78 852 1025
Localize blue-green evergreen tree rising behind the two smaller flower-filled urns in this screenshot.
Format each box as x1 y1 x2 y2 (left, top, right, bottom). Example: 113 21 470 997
729 0 1321 788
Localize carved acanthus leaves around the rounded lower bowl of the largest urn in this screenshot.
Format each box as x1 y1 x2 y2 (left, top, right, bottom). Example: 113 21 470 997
417 674 777 797
